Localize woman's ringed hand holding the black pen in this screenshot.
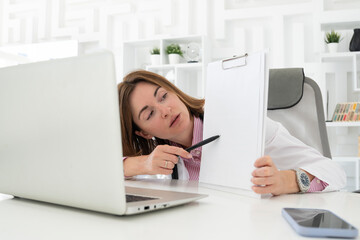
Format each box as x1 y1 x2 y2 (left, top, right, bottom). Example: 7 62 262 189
124 145 192 177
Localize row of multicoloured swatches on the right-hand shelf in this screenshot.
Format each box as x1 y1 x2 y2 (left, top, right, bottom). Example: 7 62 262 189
332 102 360 122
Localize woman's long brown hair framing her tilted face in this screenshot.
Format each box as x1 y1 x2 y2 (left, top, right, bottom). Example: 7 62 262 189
118 70 205 157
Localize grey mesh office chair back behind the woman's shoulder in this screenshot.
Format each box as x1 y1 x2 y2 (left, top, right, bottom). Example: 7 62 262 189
267 68 331 158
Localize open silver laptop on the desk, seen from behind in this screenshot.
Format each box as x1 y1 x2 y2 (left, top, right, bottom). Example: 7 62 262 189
0 52 206 215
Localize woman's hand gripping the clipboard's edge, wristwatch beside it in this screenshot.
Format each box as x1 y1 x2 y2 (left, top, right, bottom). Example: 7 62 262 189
251 156 299 195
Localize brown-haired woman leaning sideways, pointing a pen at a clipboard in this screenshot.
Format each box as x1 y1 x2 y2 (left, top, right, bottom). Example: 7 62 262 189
118 71 346 195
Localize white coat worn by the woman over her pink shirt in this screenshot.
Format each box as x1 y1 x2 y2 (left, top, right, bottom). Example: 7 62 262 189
176 118 346 192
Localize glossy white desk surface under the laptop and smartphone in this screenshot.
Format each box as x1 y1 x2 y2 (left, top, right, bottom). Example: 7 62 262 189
0 180 360 240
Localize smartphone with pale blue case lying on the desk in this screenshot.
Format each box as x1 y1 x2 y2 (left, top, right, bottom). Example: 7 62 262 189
282 208 358 238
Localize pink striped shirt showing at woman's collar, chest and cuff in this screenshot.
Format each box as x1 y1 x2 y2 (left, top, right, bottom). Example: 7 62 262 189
171 117 328 192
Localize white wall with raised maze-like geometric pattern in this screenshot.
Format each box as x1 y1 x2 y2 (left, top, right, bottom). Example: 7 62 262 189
0 0 360 67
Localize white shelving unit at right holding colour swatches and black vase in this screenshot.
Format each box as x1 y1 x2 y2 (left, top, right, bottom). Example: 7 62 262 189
317 0 360 190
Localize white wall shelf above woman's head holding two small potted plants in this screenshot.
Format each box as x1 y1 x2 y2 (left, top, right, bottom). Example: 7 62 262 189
123 35 209 98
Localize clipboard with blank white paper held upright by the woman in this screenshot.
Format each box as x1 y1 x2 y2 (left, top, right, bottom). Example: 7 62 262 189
199 51 268 198
